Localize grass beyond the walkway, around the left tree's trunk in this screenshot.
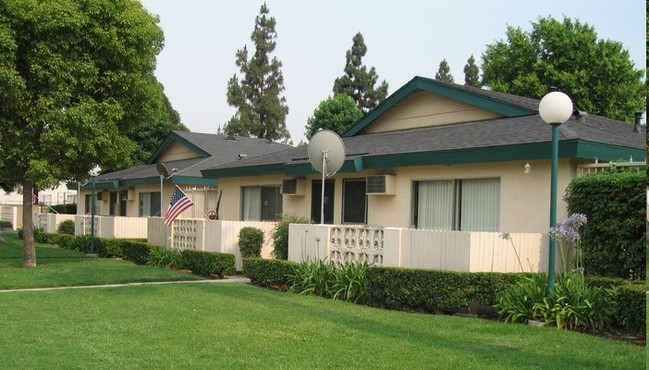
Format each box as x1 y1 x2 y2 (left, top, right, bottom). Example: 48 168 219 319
0 233 201 289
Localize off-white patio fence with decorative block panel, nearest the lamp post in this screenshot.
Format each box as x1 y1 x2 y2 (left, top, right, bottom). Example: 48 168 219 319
289 224 560 272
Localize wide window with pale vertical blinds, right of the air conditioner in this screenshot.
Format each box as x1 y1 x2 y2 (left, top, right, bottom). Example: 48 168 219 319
413 179 500 231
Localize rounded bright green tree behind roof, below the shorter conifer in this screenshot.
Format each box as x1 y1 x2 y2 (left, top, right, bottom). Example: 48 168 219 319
305 94 363 139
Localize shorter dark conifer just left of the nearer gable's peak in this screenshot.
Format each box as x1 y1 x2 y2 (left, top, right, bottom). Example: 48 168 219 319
333 32 388 112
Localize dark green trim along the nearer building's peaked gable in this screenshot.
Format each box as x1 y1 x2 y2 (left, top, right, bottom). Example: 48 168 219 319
342 76 538 137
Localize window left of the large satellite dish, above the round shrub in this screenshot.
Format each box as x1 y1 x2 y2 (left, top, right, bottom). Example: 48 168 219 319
241 185 282 221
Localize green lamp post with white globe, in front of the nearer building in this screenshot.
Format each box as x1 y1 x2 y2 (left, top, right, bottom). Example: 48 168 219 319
539 91 572 291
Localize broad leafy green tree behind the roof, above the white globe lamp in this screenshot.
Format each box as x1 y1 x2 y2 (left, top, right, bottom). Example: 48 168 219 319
482 17 646 121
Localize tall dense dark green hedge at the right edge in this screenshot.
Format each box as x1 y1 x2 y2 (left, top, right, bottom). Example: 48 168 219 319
565 172 647 280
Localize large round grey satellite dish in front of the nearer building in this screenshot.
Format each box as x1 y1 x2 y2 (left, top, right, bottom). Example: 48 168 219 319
308 130 345 176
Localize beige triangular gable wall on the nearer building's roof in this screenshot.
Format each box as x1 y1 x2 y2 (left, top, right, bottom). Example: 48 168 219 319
362 91 501 134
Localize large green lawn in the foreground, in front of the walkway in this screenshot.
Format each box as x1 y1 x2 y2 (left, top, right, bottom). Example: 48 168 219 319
0 233 645 370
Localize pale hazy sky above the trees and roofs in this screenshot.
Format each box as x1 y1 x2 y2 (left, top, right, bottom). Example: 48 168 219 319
141 0 646 145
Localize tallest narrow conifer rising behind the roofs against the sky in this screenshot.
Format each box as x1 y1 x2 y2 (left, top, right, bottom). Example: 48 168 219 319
223 3 291 140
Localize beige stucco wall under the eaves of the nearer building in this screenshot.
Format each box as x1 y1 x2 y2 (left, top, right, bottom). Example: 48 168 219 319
219 160 577 233
